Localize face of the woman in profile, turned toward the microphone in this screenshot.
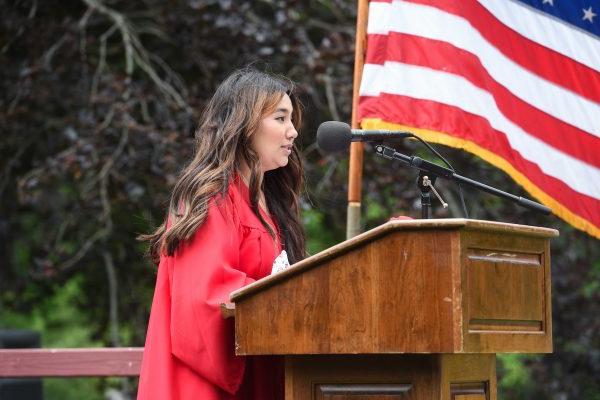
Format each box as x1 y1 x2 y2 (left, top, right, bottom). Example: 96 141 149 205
251 94 298 172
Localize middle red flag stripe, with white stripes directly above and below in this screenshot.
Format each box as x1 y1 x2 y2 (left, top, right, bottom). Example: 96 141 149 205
365 32 600 168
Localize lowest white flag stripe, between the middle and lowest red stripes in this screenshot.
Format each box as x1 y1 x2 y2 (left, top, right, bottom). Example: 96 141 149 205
360 62 600 200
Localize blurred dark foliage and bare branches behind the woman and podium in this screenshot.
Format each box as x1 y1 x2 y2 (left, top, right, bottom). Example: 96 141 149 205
0 0 600 400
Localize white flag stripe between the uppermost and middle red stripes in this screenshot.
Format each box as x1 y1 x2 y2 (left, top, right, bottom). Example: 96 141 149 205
368 2 600 137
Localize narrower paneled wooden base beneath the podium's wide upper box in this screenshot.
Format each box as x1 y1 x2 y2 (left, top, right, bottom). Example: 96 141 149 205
285 354 497 400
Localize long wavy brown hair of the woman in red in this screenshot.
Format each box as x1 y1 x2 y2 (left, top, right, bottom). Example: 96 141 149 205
140 68 306 263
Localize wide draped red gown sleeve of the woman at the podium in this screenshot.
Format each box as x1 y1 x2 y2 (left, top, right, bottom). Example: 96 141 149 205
169 196 253 394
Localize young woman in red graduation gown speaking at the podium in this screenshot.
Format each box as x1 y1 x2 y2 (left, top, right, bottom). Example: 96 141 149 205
138 69 305 400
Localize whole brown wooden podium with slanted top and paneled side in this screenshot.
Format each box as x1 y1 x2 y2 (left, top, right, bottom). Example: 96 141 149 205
231 219 558 400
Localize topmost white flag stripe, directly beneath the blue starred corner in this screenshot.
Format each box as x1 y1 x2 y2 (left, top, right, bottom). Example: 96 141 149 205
478 0 600 72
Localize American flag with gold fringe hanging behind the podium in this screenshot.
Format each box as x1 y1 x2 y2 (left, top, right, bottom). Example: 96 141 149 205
358 0 600 238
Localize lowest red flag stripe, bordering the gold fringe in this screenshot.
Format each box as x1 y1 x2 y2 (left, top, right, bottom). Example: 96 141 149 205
359 93 600 227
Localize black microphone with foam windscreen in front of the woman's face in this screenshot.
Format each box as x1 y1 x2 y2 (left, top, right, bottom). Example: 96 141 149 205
317 121 414 152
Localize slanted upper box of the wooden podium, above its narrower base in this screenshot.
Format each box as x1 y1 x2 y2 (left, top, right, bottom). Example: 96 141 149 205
231 220 556 354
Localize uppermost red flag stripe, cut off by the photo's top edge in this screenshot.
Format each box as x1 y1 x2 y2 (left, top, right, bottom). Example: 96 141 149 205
398 0 600 103
